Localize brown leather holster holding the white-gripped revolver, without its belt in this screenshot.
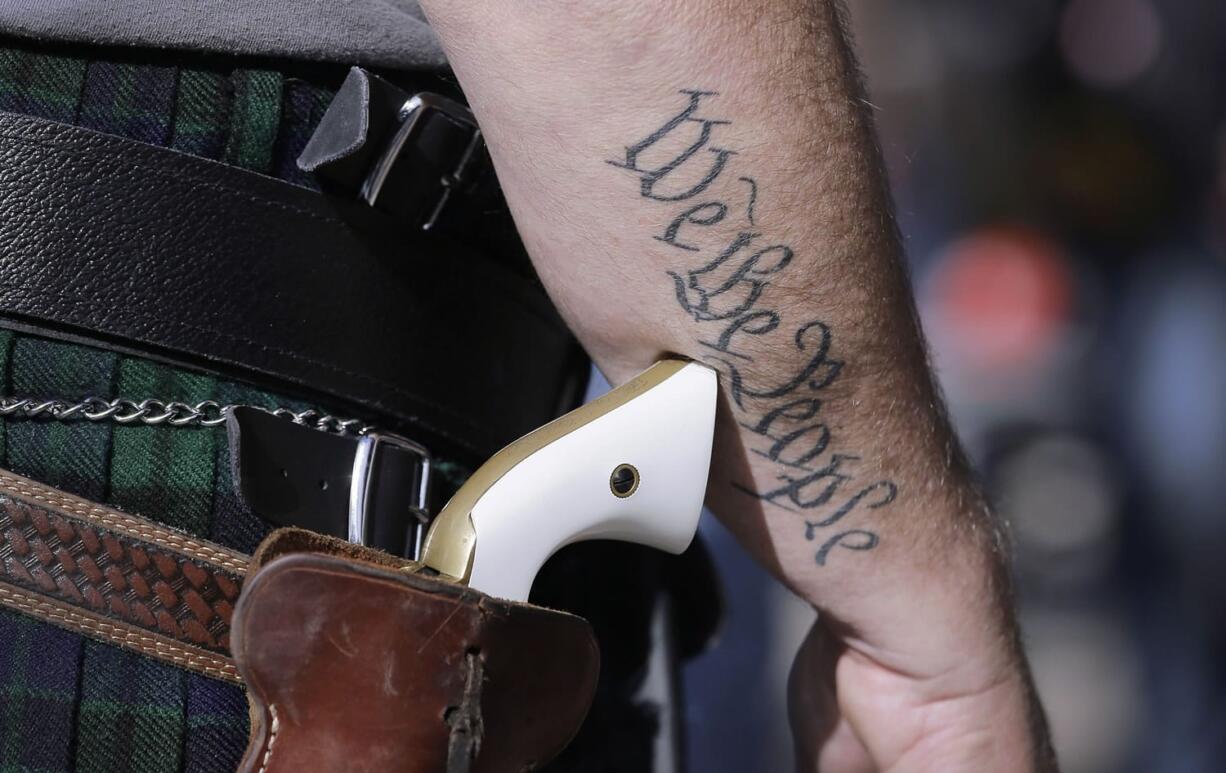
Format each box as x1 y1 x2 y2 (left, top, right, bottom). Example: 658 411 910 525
232 529 600 773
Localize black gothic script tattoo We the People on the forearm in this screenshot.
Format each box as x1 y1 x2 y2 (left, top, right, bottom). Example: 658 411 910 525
608 89 899 566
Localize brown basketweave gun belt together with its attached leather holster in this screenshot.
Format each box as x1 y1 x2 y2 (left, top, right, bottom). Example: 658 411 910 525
0 470 600 773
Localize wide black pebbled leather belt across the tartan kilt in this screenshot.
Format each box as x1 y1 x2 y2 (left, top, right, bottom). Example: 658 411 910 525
0 114 586 461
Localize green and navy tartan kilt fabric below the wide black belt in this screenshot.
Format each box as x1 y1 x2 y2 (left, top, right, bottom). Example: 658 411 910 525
0 331 296 773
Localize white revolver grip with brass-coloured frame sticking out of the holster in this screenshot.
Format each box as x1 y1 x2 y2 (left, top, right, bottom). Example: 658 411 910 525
423 360 716 600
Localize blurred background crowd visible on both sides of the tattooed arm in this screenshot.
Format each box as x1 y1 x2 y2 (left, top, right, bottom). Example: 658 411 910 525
684 0 1226 773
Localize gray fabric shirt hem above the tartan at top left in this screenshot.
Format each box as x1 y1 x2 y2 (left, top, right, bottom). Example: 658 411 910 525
0 0 445 70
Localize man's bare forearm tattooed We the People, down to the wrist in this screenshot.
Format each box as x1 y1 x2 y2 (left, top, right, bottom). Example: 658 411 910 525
424 0 1049 769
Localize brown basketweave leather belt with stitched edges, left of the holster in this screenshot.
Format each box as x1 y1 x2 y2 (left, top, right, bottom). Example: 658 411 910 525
0 470 248 682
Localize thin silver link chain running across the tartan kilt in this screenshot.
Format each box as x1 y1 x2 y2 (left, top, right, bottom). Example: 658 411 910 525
0 397 375 435
